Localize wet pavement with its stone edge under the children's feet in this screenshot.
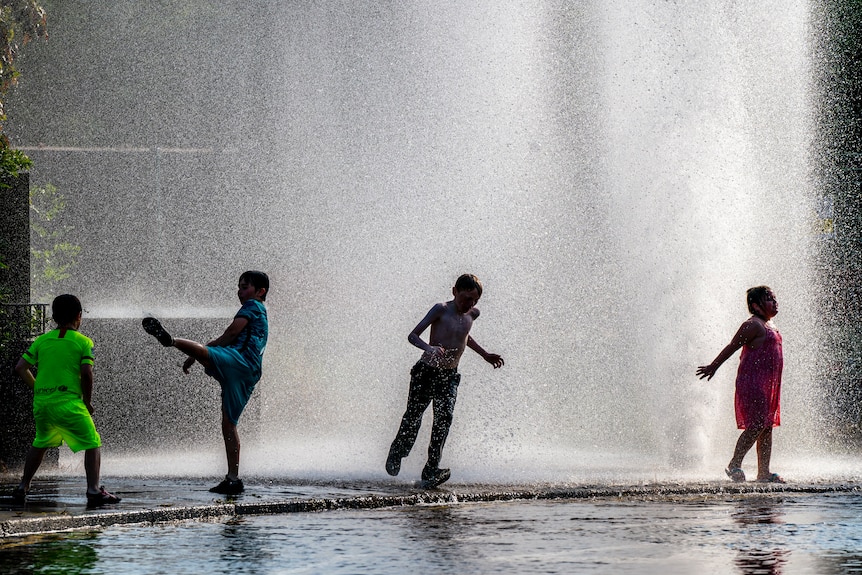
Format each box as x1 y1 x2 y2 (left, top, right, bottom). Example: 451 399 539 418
0 475 862 538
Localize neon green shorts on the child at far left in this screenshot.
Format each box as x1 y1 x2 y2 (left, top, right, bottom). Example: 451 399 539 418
33 398 102 453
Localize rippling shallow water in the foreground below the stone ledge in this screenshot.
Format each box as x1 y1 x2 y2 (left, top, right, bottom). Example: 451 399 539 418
5 493 862 575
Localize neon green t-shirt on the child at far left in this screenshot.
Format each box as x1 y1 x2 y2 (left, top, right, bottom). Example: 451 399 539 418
22 329 93 403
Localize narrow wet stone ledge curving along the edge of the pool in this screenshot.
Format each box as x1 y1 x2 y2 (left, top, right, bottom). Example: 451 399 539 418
0 483 862 538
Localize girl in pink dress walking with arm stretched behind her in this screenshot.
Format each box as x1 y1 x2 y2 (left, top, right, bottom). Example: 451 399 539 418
697 286 784 483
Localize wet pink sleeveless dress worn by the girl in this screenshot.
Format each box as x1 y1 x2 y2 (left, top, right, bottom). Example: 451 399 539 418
735 324 784 429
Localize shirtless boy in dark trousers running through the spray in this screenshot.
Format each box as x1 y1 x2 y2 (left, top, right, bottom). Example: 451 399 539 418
386 274 504 487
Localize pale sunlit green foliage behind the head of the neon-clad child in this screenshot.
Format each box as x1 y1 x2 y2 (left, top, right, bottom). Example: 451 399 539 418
30 184 81 301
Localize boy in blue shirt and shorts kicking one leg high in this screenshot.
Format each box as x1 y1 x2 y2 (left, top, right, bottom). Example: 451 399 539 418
142 271 269 495
